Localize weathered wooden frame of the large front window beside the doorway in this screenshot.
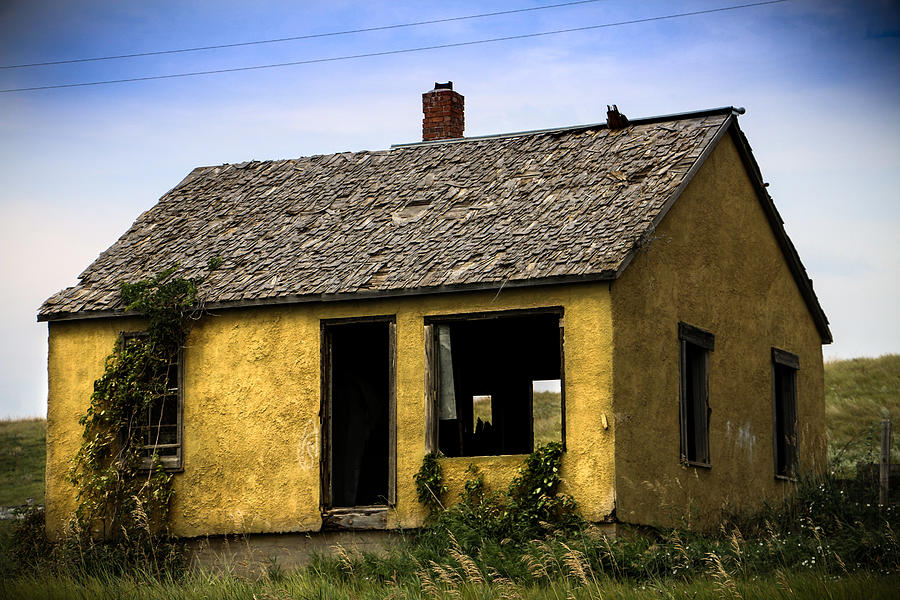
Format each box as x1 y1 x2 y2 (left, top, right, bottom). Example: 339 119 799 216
423 306 566 458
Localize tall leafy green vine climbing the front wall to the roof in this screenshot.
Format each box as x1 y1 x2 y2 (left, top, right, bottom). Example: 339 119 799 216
70 261 217 540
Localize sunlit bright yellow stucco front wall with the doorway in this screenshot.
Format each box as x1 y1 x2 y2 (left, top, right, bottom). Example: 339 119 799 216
47 283 614 536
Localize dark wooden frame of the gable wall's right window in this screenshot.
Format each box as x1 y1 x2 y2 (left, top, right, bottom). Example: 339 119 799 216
772 347 800 481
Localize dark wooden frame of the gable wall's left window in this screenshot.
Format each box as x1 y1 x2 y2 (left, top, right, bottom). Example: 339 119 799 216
678 322 715 469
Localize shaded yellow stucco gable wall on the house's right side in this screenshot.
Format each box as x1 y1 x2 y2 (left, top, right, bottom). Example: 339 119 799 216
611 136 825 526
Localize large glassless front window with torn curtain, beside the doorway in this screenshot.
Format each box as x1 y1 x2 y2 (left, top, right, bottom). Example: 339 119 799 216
426 309 565 456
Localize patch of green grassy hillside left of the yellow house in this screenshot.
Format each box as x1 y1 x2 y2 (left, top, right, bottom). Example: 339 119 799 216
0 419 47 506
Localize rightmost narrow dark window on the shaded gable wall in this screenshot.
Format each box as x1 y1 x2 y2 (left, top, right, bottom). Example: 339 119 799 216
772 348 800 479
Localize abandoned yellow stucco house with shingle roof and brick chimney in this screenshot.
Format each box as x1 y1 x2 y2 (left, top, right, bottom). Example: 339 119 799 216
38 84 831 537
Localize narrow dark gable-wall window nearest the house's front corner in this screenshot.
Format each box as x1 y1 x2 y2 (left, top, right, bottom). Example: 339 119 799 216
678 323 715 467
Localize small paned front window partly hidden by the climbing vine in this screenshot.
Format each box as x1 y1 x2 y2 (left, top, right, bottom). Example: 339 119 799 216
122 332 182 470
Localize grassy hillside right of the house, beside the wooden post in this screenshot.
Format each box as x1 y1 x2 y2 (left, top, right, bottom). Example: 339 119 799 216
825 354 900 471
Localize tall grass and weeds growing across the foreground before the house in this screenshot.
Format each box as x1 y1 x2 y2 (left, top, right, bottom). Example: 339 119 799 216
0 460 900 600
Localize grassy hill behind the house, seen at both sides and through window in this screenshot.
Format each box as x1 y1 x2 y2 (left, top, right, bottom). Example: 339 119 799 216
0 354 900 506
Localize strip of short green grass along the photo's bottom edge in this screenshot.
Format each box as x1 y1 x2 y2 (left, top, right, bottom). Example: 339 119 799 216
0 570 900 600
